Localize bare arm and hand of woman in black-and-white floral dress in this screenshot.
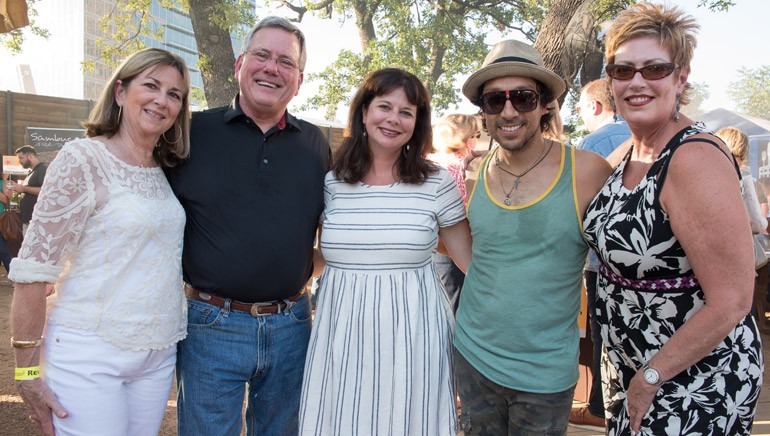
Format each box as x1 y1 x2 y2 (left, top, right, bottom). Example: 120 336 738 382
627 138 754 431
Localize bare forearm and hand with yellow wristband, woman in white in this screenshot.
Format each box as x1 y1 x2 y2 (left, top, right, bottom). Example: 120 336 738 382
11 282 67 435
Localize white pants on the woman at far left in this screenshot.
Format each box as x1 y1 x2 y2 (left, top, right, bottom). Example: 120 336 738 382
43 325 176 436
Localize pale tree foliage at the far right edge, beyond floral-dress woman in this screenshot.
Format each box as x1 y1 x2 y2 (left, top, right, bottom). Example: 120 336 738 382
727 65 770 120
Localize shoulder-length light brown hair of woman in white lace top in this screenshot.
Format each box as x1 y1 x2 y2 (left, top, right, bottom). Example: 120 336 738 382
83 48 190 167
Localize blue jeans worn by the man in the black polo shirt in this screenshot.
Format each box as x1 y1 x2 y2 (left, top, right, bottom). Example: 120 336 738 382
176 295 311 436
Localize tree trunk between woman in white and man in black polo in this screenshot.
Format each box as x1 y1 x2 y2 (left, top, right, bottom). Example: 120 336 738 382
189 0 238 107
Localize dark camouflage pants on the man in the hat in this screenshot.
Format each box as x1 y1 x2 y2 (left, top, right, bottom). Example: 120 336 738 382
454 349 575 436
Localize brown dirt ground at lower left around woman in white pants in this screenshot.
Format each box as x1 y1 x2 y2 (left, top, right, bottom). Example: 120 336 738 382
0 267 176 436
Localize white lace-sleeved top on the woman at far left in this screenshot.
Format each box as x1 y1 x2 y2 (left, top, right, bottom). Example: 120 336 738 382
9 139 187 350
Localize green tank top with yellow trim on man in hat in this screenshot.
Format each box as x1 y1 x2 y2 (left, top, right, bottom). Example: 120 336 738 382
455 145 588 393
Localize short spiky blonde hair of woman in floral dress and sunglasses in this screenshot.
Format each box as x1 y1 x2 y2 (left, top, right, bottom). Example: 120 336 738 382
604 3 700 106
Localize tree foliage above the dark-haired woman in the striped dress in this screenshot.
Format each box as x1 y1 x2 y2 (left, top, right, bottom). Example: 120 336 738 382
280 0 551 118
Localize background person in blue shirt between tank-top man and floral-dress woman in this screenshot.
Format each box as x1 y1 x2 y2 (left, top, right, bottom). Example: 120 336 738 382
569 79 631 428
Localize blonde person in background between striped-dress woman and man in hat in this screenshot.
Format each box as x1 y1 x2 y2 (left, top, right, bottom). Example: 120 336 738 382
428 114 481 313
